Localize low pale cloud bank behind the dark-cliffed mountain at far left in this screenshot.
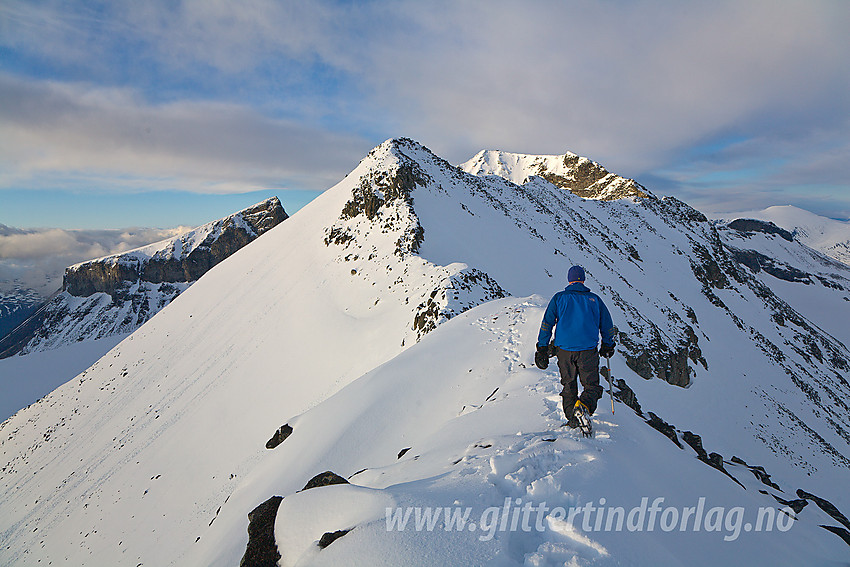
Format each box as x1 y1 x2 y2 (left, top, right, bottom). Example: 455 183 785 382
0 224 188 296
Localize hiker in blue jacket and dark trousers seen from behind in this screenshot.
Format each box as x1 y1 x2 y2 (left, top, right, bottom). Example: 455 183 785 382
534 266 615 427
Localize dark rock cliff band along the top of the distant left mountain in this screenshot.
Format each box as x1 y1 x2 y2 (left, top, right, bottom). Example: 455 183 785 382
63 197 288 298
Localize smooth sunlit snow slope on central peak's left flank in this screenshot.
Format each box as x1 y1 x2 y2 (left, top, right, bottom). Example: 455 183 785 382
0 141 503 565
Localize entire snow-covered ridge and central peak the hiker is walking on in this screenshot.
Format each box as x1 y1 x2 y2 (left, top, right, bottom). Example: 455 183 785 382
0 140 850 566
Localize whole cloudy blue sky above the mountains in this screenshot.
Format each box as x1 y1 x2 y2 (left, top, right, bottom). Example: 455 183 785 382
0 0 850 234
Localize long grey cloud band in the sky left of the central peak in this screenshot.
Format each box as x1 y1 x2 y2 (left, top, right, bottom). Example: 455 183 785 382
0 75 370 193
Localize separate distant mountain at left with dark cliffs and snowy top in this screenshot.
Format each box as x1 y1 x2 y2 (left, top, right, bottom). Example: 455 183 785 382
0 197 287 357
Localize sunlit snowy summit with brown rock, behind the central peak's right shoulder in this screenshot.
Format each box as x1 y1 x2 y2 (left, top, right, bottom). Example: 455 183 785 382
460 150 652 200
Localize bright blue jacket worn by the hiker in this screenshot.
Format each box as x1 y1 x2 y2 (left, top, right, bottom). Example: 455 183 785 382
537 282 614 351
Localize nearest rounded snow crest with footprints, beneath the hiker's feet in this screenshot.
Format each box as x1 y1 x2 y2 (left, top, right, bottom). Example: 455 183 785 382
192 296 848 566
